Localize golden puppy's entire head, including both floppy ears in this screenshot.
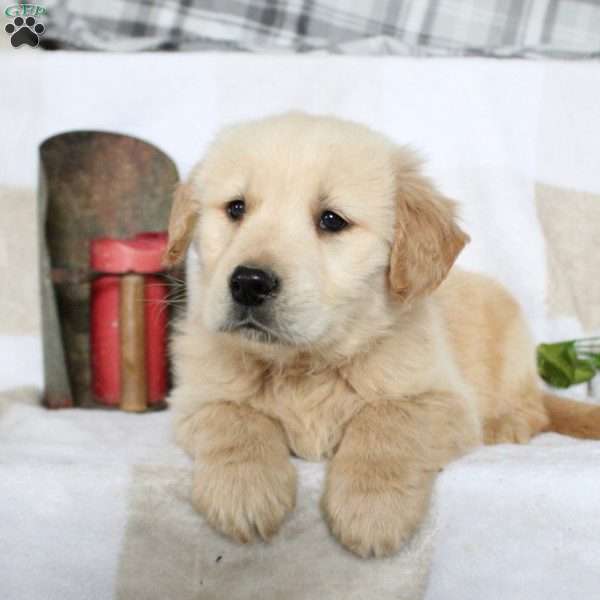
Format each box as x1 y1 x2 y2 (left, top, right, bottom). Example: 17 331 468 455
165 114 466 350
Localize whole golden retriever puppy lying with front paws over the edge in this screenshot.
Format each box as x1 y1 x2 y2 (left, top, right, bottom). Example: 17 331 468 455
167 113 600 556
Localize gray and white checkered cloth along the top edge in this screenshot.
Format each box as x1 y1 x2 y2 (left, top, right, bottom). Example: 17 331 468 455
43 0 600 58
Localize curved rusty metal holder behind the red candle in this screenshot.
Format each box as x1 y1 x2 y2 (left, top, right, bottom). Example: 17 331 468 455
38 131 179 408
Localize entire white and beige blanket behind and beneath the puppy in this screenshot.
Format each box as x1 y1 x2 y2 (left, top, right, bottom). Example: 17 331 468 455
0 52 600 600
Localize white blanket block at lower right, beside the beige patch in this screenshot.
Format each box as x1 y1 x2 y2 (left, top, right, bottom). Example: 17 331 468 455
426 434 600 600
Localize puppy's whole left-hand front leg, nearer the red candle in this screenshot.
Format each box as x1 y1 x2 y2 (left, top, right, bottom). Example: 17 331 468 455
177 402 296 543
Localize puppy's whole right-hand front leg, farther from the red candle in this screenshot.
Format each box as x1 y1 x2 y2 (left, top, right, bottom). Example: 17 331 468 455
322 394 480 557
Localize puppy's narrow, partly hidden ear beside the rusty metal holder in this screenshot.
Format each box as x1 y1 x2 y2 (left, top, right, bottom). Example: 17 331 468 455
163 183 198 267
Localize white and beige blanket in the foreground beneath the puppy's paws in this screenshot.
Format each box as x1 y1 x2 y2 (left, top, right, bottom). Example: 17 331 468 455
0 392 600 600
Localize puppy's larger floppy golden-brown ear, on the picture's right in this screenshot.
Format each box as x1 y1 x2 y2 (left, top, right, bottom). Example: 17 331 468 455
390 151 470 300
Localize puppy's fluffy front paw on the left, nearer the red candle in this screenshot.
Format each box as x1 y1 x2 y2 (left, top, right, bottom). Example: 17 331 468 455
192 460 296 543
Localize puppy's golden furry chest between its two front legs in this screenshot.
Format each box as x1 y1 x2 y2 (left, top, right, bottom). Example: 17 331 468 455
253 373 363 460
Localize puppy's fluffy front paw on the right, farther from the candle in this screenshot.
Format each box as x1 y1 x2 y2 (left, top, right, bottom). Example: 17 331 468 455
322 470 428 558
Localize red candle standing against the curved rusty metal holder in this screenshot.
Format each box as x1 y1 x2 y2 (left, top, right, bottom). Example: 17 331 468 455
90 232 168 410
